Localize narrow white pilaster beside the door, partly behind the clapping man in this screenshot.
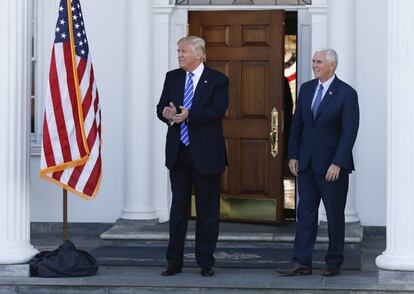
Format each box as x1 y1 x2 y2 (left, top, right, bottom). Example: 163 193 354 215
151 0 174 222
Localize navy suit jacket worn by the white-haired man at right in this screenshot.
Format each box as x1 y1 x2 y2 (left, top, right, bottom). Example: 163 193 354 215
289 77 359 174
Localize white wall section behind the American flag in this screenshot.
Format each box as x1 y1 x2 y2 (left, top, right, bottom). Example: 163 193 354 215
30 0 128 222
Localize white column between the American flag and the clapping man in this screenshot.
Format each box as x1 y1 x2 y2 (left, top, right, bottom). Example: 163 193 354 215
122 0 161 219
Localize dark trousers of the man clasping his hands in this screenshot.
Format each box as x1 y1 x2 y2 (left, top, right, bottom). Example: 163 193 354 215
167 144 221 268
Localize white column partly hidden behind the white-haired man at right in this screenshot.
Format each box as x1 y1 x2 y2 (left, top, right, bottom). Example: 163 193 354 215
325 0 359 223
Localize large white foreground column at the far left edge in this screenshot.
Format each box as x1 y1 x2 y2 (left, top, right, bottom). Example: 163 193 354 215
0 0 37 264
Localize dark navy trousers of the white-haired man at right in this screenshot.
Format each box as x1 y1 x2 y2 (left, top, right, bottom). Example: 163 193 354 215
293 165 349 268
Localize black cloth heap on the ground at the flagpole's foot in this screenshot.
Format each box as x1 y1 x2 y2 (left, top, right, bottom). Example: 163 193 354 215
30 240 99 277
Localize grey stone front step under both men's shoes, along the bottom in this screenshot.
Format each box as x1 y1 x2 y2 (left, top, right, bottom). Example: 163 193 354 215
0 266 414 294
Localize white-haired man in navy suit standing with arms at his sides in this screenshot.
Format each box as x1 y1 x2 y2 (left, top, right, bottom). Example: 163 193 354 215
276 49 359 276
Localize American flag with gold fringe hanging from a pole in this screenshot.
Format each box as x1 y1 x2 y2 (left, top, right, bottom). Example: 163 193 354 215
40 0 102 199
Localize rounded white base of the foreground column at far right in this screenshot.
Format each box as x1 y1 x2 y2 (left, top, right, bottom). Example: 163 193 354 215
375 250 414 272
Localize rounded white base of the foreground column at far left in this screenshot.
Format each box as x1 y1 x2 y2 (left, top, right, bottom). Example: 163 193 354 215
0 244 39 264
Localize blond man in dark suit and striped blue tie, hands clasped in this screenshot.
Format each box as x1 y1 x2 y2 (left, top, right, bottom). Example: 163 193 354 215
157 36 229 276
